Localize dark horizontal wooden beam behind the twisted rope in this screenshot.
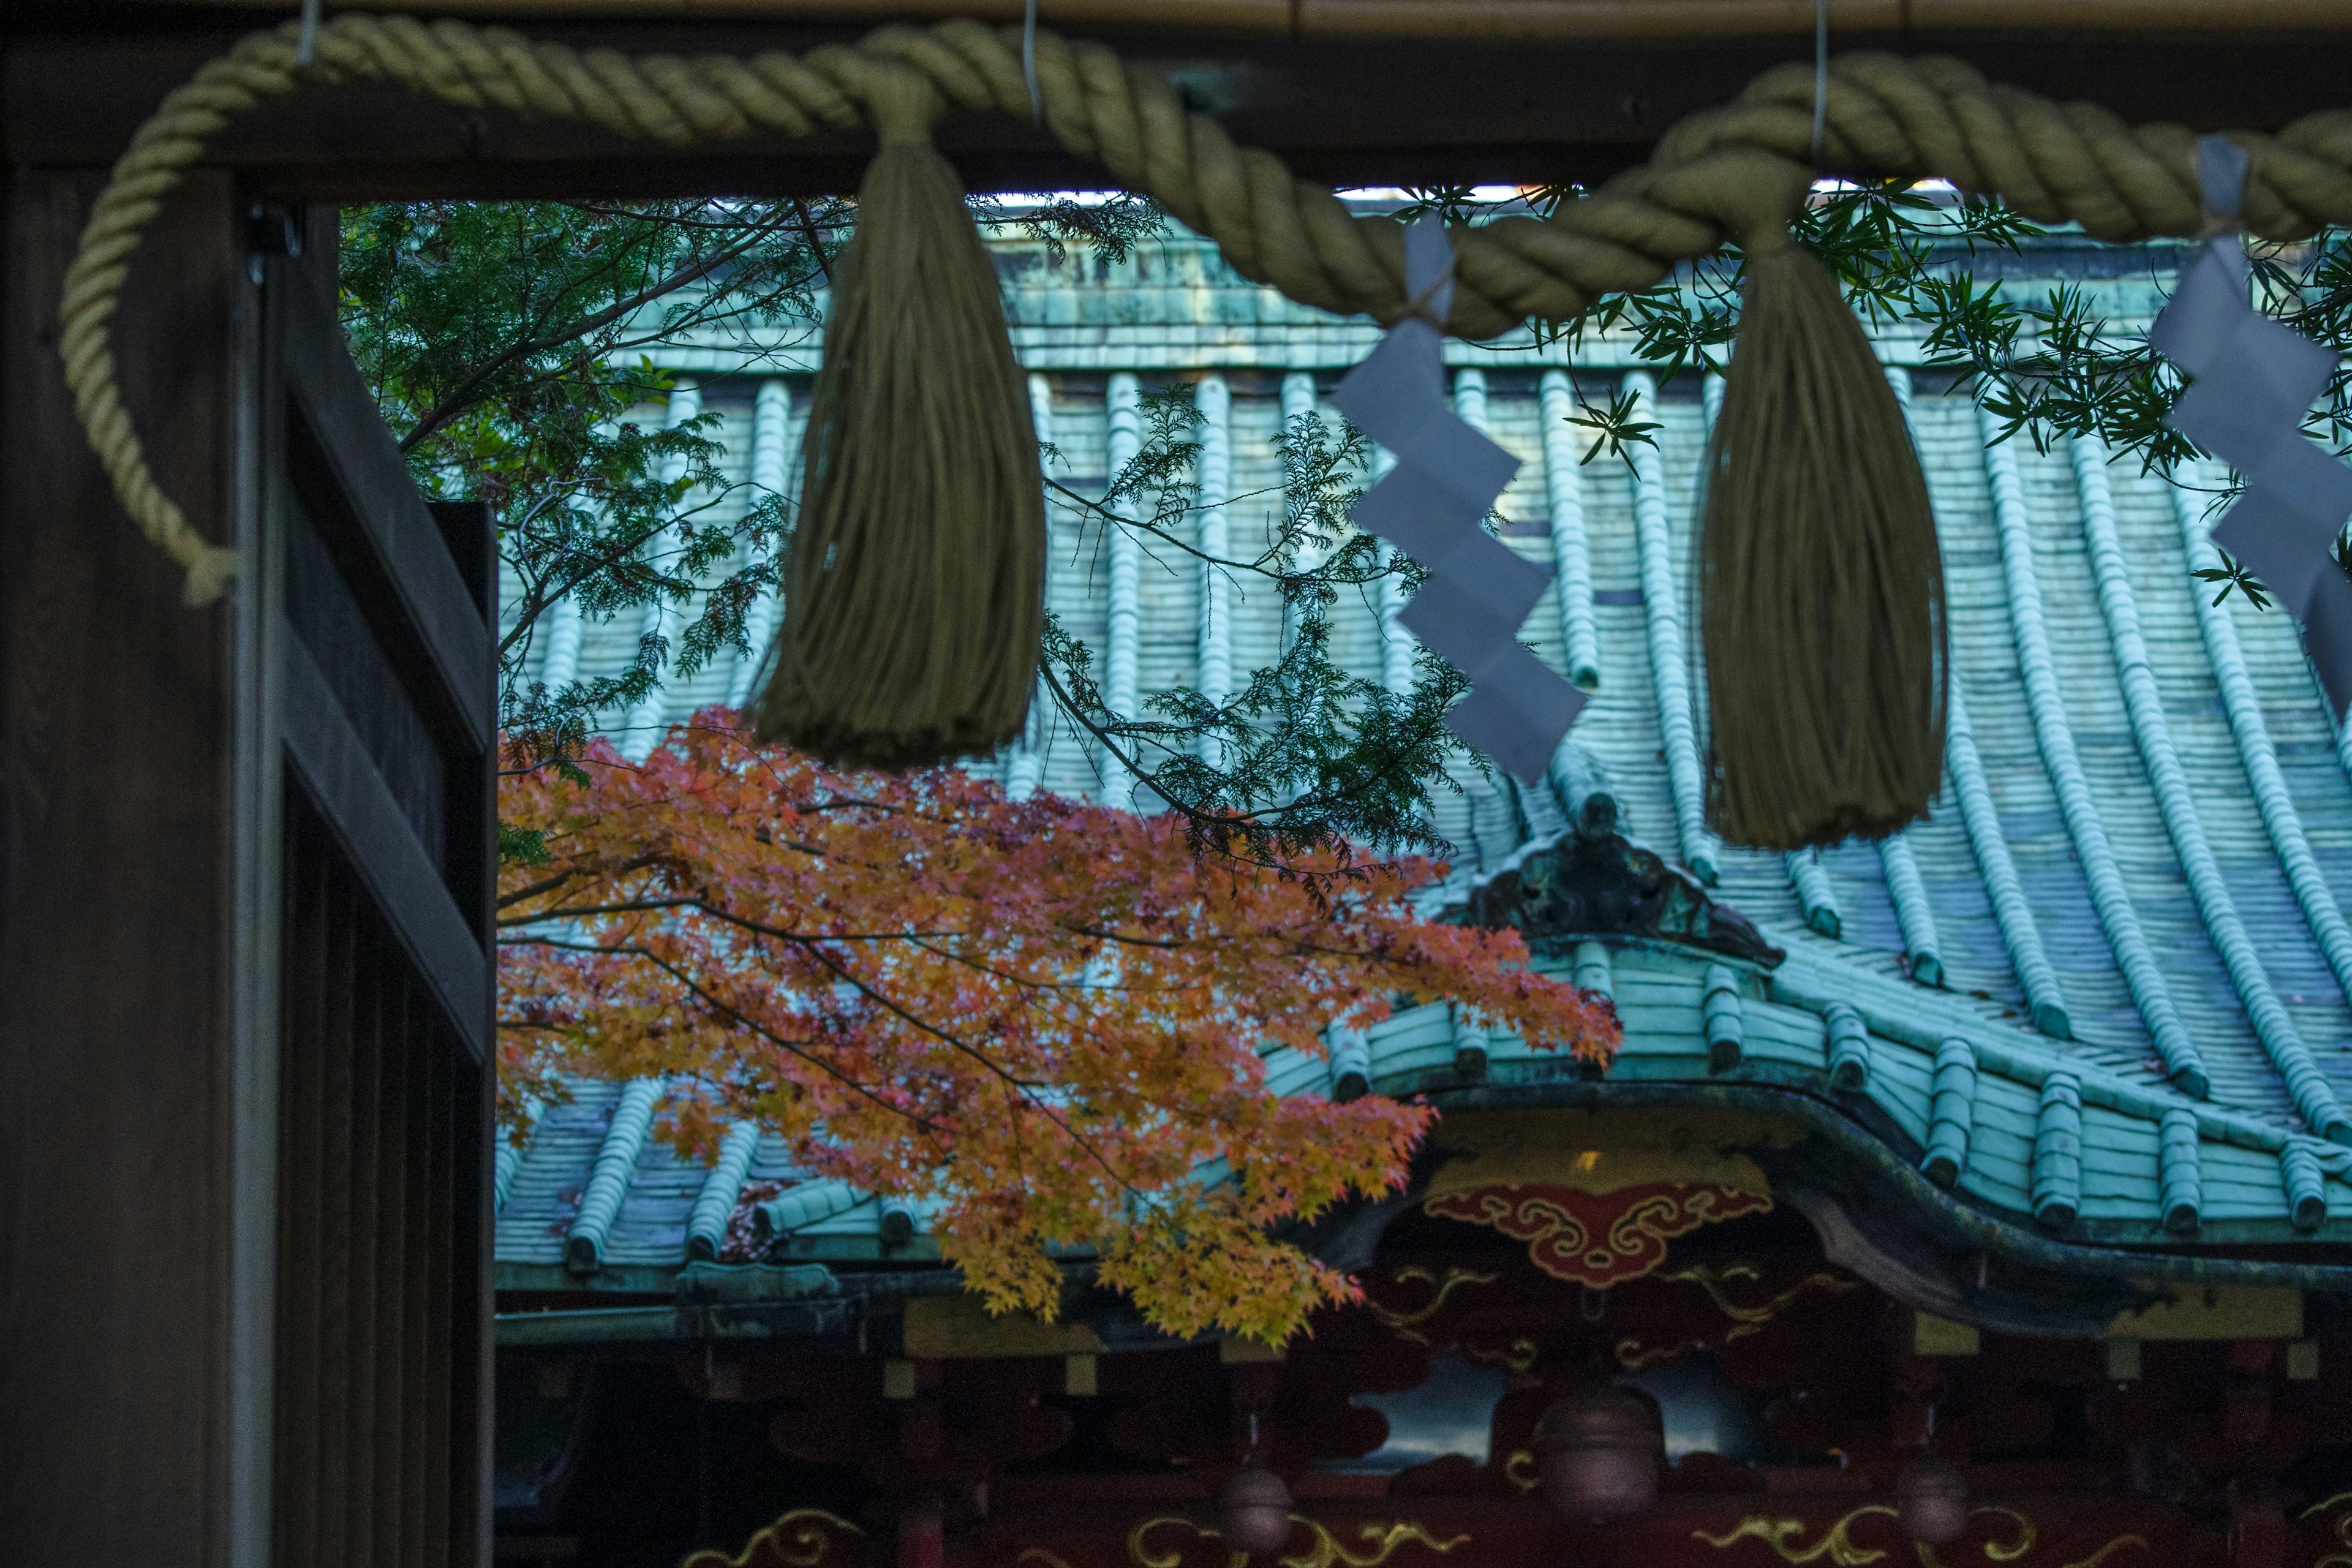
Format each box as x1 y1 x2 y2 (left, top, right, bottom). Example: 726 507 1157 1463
13 7 2352 202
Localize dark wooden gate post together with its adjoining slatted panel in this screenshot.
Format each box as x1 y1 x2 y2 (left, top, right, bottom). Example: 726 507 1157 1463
0 148 494 1568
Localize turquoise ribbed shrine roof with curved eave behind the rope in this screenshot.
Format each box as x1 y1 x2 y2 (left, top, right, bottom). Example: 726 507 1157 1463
499 221 2352 1288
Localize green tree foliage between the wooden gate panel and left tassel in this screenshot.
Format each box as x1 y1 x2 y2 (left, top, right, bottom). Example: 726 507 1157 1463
341 200 849 766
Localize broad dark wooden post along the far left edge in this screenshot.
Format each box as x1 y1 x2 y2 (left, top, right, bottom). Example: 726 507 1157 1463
0 169 246 1568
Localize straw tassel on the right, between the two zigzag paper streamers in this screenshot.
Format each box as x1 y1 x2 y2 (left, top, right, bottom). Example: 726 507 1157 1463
1698 228 1945 849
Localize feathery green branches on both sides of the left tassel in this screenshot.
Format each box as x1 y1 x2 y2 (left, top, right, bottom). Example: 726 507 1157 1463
341 195 1461 865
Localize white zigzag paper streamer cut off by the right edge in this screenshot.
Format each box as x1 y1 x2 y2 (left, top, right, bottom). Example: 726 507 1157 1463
2147 137 2352 724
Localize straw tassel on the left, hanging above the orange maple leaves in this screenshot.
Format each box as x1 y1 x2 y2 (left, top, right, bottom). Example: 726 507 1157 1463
755 66 1044 766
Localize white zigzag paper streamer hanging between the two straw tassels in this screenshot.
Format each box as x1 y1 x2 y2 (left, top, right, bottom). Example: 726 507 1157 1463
1331 219 1585 783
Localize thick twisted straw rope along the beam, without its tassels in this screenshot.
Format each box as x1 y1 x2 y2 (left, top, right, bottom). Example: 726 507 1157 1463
61 14 2352 604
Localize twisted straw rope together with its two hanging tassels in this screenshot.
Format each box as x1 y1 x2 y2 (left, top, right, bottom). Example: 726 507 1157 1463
59 12 2352 823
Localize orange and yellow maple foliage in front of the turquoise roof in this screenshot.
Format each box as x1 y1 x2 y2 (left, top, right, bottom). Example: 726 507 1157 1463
501 710 1618 1340
